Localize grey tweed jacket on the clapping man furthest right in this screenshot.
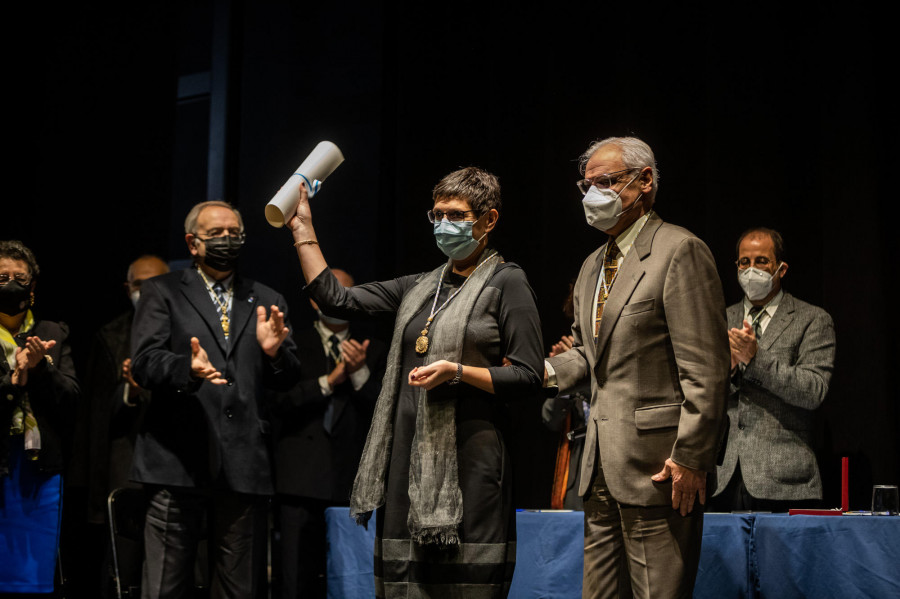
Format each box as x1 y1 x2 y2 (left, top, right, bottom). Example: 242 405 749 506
716 293 834 500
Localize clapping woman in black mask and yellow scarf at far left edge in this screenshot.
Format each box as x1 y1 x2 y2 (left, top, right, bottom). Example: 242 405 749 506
0 241 80 593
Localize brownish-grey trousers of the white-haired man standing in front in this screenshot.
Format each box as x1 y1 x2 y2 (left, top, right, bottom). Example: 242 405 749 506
582 468 703 599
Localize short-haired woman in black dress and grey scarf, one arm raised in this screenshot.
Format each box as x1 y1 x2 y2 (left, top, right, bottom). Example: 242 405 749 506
290 167 543 597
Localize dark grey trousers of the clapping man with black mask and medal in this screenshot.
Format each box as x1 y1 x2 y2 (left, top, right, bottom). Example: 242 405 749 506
141 486 266 599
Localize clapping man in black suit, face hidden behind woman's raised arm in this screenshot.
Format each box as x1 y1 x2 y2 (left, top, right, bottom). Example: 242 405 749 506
275 269 386 599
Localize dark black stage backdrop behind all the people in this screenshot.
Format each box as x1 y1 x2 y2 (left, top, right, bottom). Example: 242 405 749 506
0 0 900 508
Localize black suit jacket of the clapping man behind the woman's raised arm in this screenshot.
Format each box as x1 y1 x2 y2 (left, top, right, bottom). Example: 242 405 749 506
275 328 387 503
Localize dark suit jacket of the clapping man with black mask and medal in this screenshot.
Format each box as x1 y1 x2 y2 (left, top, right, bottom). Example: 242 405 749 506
132 269 300 495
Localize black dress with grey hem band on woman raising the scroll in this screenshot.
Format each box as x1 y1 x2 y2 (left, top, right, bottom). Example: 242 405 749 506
308 263 543 597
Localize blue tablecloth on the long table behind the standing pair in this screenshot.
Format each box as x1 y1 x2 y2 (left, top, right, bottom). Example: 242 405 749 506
326 508 900 599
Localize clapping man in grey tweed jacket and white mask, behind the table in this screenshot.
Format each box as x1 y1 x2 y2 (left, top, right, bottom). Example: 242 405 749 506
711 228 834 512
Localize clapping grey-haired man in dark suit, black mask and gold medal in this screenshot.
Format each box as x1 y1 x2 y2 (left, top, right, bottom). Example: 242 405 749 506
131 202 300 599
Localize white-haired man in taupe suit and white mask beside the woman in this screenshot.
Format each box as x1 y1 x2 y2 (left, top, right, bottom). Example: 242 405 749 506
547 137 729 599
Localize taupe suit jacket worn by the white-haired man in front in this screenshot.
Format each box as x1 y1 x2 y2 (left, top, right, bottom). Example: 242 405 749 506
549 213 730 506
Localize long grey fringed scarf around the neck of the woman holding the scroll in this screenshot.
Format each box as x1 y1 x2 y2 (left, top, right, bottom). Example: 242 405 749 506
350 250 503 545
